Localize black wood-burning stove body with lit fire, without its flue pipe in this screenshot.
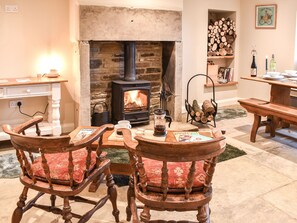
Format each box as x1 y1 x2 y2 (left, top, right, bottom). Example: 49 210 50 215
112 80 151 124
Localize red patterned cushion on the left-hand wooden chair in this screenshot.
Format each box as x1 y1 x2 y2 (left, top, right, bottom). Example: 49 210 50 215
32 148 96 183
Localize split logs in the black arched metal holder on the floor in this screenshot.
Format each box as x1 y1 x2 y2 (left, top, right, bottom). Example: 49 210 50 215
190 100 216 124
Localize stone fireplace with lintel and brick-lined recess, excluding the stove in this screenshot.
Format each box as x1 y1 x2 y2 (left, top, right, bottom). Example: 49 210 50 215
78 6 183 125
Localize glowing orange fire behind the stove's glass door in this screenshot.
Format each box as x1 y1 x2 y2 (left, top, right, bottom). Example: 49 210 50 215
124 90 147 111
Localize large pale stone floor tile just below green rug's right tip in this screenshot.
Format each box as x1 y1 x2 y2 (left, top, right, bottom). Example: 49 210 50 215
213 156 293 208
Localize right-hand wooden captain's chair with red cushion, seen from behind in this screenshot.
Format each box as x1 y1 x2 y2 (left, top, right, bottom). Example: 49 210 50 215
123 130 225 223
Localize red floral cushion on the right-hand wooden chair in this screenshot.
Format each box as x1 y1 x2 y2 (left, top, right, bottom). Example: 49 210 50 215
143 158 206 189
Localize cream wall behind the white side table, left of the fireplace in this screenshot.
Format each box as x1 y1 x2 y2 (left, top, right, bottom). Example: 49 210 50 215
0 0 74 131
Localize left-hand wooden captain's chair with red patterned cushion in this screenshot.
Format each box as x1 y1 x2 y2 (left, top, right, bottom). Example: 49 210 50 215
2 117 119 223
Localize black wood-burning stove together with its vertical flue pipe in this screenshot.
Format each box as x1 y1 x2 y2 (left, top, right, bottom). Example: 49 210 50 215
112 41 151 124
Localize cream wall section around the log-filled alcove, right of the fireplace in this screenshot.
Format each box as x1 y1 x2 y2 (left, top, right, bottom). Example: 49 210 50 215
182 0 240 105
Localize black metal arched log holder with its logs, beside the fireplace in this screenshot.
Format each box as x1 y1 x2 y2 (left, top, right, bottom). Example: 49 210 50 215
185 74 218 127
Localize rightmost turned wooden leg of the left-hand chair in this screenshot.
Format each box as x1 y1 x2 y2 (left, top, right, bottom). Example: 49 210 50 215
105 168 120 222
